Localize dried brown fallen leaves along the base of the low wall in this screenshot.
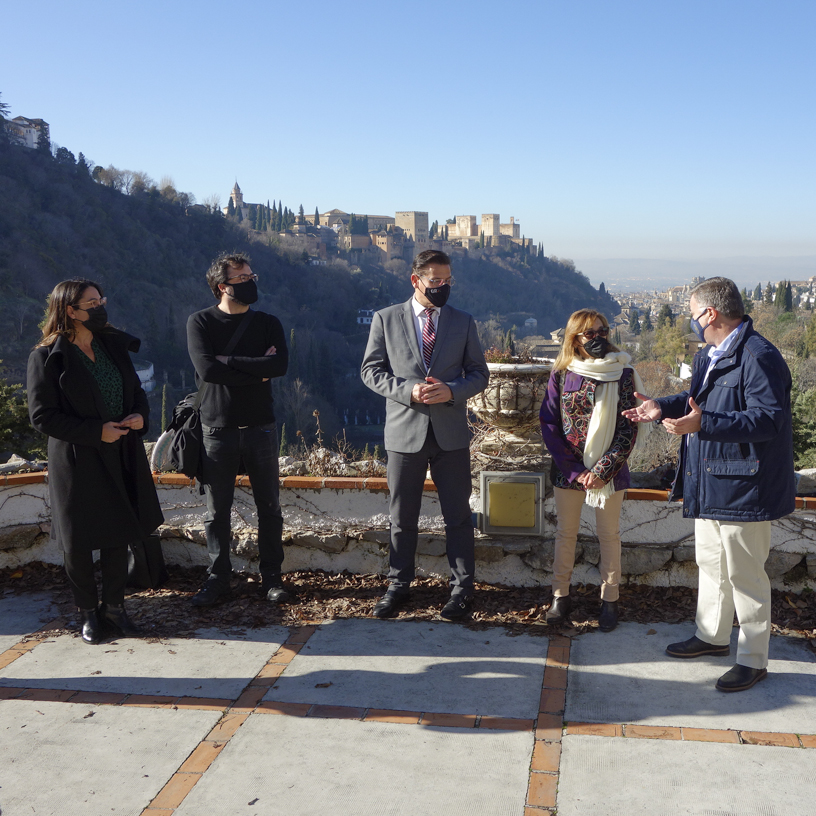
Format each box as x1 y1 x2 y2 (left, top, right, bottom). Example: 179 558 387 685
0 563 816 645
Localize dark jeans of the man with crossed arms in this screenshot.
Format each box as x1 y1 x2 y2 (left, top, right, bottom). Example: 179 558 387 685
202 422 283 583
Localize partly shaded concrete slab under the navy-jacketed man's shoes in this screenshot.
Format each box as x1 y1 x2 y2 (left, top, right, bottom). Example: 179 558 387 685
564 623 816 734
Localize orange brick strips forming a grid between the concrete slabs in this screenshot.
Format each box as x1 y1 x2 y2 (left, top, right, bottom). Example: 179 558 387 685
0 619 816 816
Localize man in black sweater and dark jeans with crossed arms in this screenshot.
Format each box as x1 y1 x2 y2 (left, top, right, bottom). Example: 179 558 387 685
187 253 292 606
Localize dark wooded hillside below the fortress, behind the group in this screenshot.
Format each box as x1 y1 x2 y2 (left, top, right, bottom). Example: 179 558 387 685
0 115 618 450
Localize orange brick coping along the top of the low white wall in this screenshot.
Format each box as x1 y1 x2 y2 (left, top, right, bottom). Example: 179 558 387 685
0 471 816 510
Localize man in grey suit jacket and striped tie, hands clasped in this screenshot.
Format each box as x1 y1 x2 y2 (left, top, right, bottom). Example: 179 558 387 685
361 250 489 620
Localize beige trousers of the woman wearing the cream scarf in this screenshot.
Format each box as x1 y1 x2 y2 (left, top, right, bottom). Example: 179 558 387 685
552 487 624 601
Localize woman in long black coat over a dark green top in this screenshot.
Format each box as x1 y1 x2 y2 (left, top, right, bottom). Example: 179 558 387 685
27 280 163 643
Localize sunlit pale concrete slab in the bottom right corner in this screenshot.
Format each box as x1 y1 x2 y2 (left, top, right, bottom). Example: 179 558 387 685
558 736 816 816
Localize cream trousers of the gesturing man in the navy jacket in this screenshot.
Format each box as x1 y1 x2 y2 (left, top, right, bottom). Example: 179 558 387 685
694 519 771 669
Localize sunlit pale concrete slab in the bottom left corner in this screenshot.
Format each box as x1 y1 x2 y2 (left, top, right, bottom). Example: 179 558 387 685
0 700 220 816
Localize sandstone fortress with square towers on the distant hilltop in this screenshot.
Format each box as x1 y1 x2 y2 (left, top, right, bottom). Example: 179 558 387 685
223 182 537 263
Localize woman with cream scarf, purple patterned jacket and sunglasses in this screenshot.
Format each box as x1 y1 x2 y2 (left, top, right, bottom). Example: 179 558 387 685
540 309 642 632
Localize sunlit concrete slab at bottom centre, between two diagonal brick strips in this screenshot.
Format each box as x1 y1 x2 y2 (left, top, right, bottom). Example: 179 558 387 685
175 714 533 816
